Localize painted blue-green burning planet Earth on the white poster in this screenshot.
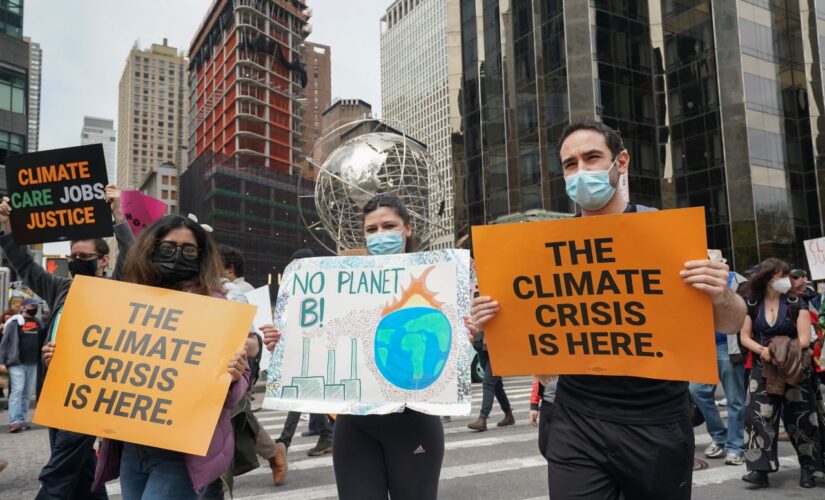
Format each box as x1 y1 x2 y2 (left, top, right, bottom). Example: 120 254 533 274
375 307 453 391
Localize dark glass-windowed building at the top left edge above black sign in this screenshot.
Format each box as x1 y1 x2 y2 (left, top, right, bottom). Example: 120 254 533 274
0 0 29 194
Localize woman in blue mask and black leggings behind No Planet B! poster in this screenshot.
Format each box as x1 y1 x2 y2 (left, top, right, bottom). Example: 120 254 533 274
264 195 450 500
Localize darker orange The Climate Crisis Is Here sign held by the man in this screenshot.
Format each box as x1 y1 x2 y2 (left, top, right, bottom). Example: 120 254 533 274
473 208 718 383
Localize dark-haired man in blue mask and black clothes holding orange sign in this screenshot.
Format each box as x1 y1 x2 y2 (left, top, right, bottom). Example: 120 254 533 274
472 121 746 500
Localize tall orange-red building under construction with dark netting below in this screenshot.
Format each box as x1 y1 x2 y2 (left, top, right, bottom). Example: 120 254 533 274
180 0 330 290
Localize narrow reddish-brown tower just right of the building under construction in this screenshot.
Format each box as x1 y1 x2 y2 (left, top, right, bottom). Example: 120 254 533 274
301 42 332 179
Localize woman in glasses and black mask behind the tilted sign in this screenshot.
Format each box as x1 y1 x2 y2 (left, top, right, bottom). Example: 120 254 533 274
90 215 278 500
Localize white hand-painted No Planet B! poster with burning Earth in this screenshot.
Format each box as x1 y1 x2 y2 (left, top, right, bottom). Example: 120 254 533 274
264 250 472 415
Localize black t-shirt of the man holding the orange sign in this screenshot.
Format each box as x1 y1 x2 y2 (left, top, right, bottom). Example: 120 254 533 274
556 204 688 425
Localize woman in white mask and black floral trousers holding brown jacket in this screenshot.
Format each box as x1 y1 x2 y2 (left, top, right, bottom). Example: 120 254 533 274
740 258 823 488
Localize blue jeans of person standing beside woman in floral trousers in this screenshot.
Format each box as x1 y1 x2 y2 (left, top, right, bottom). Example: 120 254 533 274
690 344 745 454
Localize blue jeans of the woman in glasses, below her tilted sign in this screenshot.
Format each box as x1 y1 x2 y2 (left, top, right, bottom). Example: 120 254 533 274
120 443 223 500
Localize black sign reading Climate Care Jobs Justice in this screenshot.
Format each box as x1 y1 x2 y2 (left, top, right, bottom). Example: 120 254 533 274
6 144 113 245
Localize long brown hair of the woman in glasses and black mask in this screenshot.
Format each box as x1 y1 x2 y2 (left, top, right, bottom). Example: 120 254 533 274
123 215 223 295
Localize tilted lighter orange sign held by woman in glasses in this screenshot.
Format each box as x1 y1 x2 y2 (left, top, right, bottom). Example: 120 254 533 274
34 276 255 455
